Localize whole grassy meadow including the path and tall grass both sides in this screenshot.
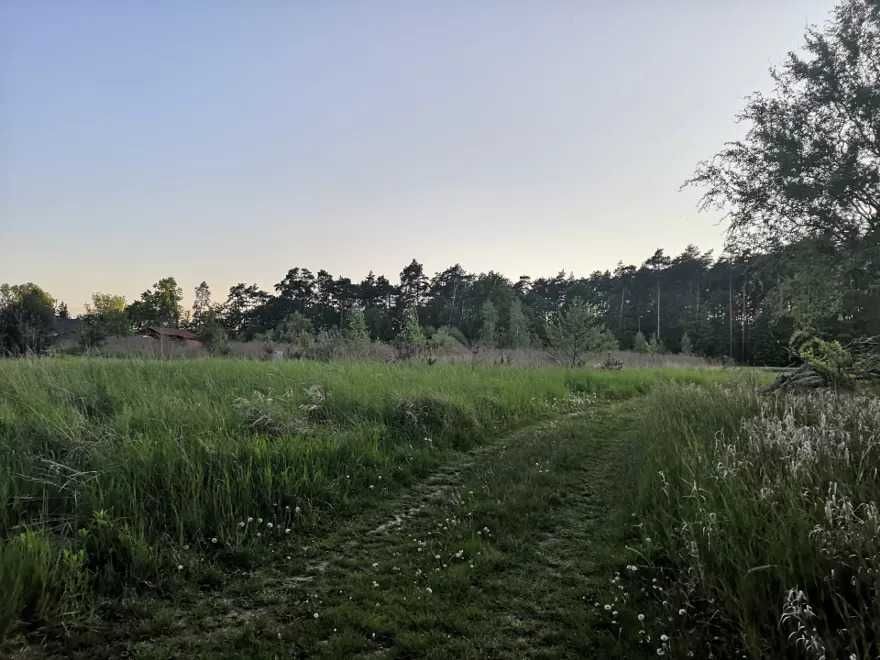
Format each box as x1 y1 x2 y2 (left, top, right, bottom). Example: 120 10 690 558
0 359 880 658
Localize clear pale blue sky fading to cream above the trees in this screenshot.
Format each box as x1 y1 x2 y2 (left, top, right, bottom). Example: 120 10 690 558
0 0 834 311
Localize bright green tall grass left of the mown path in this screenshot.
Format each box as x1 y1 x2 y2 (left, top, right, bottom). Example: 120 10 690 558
0 358 727 631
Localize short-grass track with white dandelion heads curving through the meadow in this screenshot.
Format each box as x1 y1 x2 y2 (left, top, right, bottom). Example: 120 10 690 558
32 403 633 658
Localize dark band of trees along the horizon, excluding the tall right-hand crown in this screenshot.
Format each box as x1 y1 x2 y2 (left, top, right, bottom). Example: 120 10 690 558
0 233 880 365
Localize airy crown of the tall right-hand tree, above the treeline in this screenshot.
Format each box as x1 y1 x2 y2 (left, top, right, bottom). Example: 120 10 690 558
688 0 880 251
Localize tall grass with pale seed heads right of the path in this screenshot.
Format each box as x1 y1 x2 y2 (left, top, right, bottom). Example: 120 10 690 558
639 386 880 658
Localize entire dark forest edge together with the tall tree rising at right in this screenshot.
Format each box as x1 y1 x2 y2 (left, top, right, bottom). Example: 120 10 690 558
0 0 880 365
